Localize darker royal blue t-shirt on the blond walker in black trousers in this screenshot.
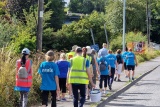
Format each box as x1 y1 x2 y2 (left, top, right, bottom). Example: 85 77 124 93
56 60 70 78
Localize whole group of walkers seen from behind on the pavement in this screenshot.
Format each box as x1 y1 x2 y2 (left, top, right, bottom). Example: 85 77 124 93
14 43 137 107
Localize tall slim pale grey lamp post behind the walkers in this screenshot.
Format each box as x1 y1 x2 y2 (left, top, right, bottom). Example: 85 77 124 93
123 0 126 52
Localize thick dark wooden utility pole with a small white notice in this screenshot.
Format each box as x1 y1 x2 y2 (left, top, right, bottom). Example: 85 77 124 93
36 0 44 51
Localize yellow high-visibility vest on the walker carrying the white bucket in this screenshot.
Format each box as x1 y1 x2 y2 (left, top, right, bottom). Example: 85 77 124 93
68 56 89 84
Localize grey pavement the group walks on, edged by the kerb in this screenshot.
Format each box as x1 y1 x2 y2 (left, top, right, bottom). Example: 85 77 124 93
32 57 160 107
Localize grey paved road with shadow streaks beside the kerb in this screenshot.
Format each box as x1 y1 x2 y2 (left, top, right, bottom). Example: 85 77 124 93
105 67 160 107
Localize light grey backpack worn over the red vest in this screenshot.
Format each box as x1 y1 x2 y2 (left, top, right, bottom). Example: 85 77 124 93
18 60 31 79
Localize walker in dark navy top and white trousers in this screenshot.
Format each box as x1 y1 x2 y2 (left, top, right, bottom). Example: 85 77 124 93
114 49 123 81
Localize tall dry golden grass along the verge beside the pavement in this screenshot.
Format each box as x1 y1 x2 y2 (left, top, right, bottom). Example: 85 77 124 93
0 48 160 107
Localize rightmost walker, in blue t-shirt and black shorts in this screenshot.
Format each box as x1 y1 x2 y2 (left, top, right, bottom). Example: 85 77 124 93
126 48 138 81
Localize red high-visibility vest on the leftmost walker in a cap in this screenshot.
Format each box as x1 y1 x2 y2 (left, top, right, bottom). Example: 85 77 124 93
16 60 32 87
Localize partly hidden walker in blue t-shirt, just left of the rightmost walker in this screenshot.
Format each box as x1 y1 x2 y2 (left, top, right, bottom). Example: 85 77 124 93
122 47 128 78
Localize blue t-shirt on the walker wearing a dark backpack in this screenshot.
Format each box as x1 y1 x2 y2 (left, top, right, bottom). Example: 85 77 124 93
98 57 110 75
